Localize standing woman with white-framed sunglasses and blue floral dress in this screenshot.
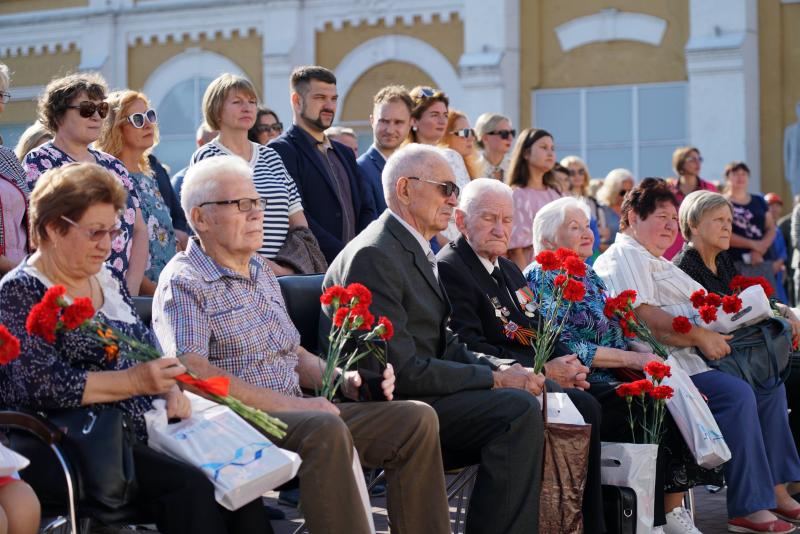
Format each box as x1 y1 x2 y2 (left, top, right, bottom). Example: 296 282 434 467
97 91 177 295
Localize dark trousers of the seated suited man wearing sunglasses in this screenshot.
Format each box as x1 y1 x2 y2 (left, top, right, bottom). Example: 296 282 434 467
432 389 543 534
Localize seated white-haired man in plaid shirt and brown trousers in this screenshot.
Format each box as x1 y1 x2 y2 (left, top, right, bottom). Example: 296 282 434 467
153 156 450 534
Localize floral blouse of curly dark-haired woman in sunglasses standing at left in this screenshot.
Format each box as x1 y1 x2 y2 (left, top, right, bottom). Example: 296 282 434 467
23 141 139 277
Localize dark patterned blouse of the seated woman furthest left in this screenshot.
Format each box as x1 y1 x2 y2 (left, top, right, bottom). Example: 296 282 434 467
0 259 155 442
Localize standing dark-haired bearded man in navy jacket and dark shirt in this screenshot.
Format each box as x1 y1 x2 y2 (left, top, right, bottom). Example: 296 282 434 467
269 67 376 263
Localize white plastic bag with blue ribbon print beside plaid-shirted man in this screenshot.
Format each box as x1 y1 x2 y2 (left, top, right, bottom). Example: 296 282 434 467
144 393 300 510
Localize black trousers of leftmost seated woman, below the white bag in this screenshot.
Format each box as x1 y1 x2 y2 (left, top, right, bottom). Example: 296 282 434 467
134 444 273 534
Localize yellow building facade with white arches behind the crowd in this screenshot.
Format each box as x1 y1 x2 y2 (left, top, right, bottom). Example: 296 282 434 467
0 0 800 200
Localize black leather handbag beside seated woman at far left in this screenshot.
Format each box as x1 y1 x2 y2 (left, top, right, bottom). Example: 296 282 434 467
11 406 138 517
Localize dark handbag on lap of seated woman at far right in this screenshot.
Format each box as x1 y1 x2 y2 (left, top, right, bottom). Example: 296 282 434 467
705 317 792 393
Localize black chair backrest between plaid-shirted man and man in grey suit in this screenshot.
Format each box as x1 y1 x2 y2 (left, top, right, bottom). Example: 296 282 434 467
278 274 324 353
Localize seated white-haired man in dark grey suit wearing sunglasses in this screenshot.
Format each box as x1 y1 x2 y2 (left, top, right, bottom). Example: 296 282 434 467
324 144 544 534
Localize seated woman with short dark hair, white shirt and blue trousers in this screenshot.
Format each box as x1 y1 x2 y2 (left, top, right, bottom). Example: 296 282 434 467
594 178 800 532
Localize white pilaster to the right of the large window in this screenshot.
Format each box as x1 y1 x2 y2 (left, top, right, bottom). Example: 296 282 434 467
686 0 761 191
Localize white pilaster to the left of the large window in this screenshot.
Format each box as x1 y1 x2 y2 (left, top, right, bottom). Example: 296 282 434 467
454 0 520 126
